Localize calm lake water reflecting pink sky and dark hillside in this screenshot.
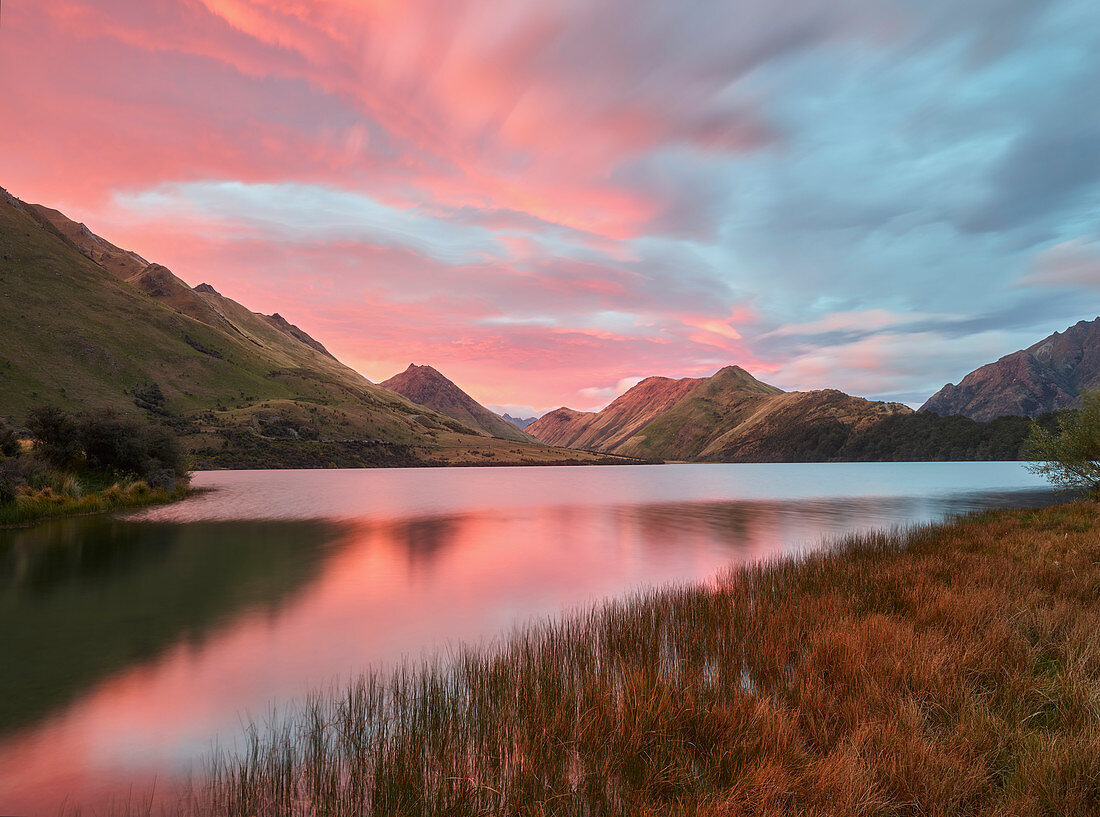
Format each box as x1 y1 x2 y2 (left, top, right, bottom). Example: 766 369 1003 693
0 463 1054 815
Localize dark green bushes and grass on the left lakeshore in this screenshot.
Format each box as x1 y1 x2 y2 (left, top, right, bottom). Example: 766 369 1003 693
0 406 188 525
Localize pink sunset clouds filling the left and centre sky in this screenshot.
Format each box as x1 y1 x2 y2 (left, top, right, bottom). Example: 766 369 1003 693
0 0 792 407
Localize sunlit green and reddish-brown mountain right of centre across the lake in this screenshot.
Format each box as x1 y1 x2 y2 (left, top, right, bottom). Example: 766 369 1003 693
528 366 912 462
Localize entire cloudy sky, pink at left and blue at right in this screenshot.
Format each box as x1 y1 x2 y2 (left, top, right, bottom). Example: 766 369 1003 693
0 0 1100 415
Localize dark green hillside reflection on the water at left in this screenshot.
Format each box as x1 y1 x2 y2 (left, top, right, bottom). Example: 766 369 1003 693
0 517 338 732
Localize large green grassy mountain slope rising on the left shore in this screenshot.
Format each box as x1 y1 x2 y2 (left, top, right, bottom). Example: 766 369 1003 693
0 190 616 467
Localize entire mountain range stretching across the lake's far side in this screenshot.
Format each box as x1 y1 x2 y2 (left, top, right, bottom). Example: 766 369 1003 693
0 185 1100 467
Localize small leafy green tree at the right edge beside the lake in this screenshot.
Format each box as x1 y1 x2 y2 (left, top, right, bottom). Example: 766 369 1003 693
1026 391 1100 501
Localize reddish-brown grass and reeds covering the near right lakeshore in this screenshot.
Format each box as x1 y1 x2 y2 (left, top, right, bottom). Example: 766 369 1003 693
157 504 1100 817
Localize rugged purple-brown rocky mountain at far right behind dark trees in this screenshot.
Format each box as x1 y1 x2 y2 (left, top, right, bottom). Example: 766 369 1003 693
920 318 1100 420
